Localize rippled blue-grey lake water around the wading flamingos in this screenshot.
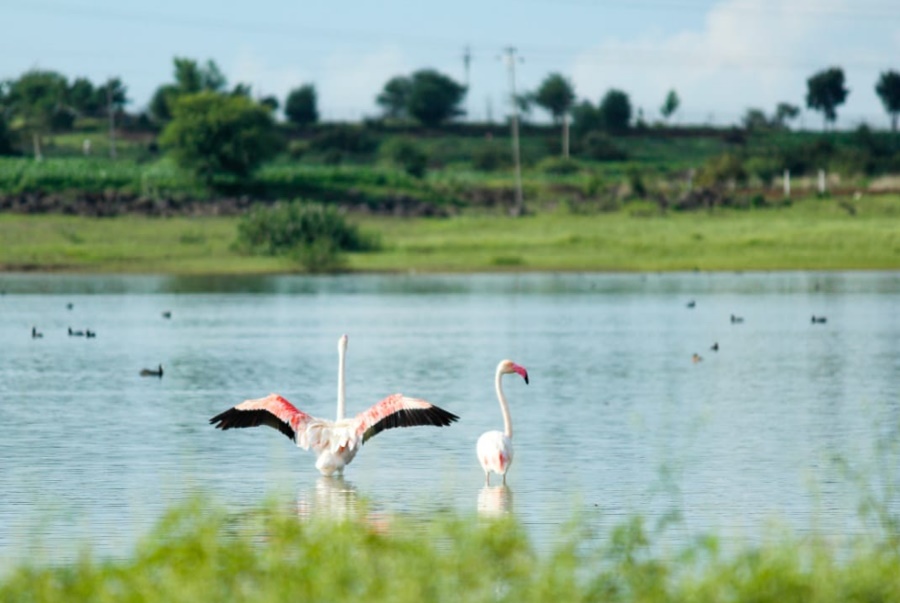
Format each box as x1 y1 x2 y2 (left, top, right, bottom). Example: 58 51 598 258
0 273 900 566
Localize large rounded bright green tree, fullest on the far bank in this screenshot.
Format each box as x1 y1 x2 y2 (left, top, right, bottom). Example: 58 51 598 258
160 90 281 183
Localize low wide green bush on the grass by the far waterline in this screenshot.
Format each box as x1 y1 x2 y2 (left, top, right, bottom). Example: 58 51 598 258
237 200 378 272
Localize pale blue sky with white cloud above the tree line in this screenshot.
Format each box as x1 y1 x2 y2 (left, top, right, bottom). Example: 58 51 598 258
0 0 900 129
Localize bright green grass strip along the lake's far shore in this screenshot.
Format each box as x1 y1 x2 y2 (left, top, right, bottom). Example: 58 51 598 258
0 196 900 274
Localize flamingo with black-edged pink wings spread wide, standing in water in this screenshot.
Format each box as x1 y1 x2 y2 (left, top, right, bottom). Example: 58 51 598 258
209 335 459 475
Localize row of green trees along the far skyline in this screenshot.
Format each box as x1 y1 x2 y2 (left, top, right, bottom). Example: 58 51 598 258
0 57 900 181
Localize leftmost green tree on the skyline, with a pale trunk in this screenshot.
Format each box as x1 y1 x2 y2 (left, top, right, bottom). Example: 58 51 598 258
9 69 68 159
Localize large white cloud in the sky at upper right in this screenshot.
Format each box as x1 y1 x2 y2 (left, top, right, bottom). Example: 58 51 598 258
572 0 897 125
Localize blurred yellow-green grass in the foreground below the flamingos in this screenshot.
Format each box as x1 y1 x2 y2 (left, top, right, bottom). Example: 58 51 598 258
0 502 900 603
